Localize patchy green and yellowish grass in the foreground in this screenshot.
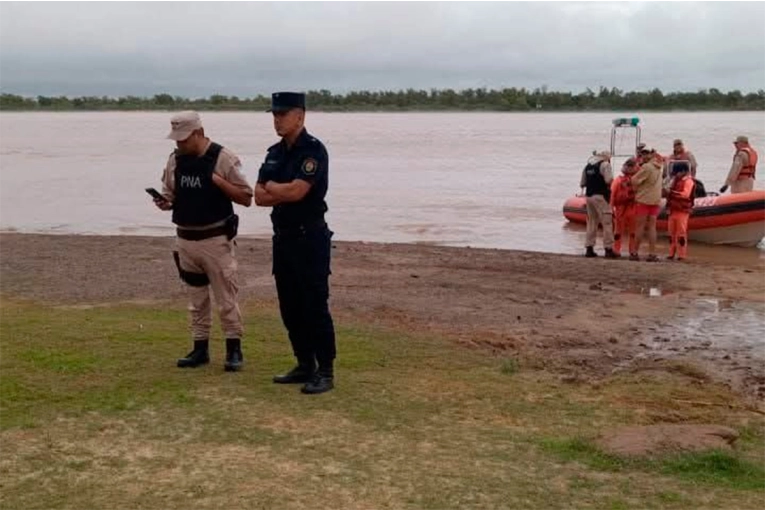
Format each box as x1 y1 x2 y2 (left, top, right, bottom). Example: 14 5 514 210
0 300 765 509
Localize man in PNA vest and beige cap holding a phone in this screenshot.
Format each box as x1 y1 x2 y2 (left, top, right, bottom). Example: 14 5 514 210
154 111 253 372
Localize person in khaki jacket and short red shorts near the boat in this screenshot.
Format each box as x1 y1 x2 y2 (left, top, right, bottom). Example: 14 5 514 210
630 148 664 262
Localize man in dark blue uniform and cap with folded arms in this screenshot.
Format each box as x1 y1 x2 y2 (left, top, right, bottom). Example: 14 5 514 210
255 92 335 394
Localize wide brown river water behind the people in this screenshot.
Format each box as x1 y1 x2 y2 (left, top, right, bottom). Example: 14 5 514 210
0 112 765 263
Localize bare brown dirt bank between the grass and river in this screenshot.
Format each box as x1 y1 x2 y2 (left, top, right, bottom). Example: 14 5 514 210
0 233 765 400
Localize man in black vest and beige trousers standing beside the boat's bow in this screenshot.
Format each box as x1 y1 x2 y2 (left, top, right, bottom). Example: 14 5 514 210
580 151 619 259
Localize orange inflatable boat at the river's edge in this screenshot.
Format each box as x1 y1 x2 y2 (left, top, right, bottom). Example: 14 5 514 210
563 190 765 246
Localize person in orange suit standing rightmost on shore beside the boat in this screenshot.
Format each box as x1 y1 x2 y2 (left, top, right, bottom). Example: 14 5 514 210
667 162 695 260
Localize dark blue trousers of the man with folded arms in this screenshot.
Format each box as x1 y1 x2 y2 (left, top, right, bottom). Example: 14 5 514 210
273 225 335 371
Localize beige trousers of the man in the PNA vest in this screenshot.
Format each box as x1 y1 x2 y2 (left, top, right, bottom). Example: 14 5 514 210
176 236 244 340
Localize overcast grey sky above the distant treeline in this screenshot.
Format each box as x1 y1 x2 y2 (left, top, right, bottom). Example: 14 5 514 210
0 0 765 97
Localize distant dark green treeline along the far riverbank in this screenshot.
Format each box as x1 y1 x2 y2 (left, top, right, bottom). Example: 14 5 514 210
0 87 765 112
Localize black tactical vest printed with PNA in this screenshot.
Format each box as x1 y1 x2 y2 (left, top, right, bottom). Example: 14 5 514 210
173 143 234 227
